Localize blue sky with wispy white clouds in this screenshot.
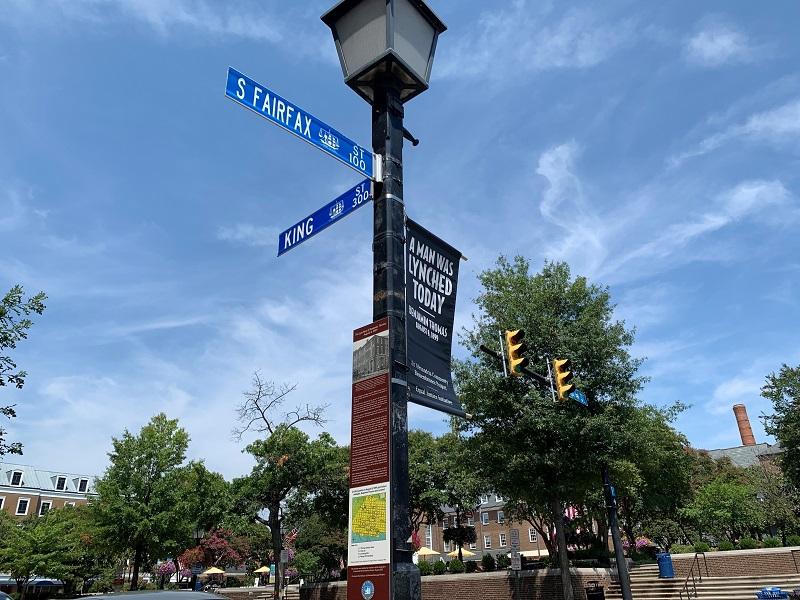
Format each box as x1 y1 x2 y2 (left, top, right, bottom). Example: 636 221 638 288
0 0 800 477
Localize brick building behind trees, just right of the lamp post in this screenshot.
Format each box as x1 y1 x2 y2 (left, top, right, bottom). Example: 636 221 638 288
417 494 547 560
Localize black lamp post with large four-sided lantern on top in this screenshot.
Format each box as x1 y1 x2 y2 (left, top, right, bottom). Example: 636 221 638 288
322 0 446 600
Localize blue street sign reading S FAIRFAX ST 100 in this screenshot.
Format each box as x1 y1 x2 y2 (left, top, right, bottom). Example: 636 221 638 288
225 67 378 179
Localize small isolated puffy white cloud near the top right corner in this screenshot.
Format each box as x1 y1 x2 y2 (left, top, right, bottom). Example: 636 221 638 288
683 23 759 67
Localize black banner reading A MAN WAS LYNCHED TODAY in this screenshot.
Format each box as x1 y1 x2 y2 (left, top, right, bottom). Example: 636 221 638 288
406 219 464 417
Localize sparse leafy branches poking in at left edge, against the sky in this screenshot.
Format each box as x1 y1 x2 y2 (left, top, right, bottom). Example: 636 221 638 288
0 285 47 457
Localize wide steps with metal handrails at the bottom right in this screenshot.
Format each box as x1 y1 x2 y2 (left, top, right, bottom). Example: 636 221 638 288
606 565 800 600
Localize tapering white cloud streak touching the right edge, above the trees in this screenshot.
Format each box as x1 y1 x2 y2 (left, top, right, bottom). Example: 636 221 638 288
670 98 800 167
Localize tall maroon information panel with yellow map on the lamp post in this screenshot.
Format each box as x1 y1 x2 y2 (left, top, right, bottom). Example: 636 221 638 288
347 318 392 600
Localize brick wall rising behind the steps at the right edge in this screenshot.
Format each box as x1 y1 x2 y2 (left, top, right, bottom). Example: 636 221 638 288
672 547 800 578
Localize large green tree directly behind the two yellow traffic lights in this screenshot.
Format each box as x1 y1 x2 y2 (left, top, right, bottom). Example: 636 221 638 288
455 257 644 598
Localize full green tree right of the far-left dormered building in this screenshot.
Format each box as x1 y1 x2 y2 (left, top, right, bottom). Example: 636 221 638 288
93 413 193 590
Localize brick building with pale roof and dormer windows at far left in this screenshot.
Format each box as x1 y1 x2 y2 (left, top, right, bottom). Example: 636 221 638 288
0 462 94 519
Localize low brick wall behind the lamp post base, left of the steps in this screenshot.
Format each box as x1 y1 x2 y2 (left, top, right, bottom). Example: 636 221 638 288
302 569 611 600
